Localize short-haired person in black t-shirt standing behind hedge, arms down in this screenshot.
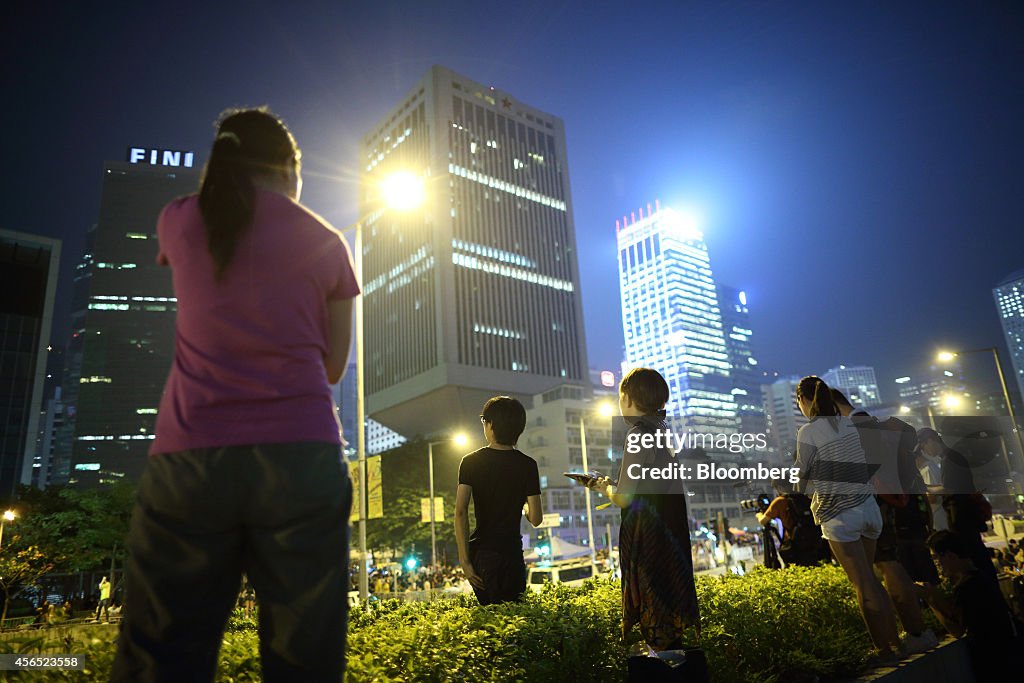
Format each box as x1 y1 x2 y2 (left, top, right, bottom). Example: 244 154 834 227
455 396 544 605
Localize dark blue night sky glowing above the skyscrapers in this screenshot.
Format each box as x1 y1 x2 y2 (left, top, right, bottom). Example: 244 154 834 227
0 0 1024 399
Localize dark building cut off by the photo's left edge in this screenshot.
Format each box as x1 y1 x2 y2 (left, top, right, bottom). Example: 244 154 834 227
0 230 60 501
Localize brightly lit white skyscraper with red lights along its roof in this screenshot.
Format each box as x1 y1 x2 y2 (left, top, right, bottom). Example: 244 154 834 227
615 206 738 432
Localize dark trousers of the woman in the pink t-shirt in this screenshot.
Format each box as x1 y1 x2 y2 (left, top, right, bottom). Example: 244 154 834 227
111 442 352 683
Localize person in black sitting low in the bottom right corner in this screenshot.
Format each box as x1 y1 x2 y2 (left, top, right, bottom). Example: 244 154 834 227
918 530 1020 681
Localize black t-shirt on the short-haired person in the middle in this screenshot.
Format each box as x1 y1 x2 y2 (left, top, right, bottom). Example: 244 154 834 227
459 446 541 550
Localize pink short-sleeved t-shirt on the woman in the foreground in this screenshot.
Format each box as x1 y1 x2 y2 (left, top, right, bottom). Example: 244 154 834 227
150 189 359 455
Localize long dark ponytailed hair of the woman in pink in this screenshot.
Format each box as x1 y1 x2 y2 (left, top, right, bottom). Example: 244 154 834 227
199 108 299 282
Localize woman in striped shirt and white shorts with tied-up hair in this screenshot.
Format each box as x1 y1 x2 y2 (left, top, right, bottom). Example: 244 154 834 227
796 376 899 661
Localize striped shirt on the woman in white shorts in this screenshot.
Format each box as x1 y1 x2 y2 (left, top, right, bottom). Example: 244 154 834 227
796 417 874 524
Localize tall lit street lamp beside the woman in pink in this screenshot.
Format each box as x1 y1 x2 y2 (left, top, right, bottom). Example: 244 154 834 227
344 171 425 600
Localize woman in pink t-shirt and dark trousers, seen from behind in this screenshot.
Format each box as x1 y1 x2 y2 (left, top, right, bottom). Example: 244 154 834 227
112 109 359 681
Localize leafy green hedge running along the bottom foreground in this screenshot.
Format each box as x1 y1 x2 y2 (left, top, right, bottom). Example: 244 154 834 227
0 567 925 682
